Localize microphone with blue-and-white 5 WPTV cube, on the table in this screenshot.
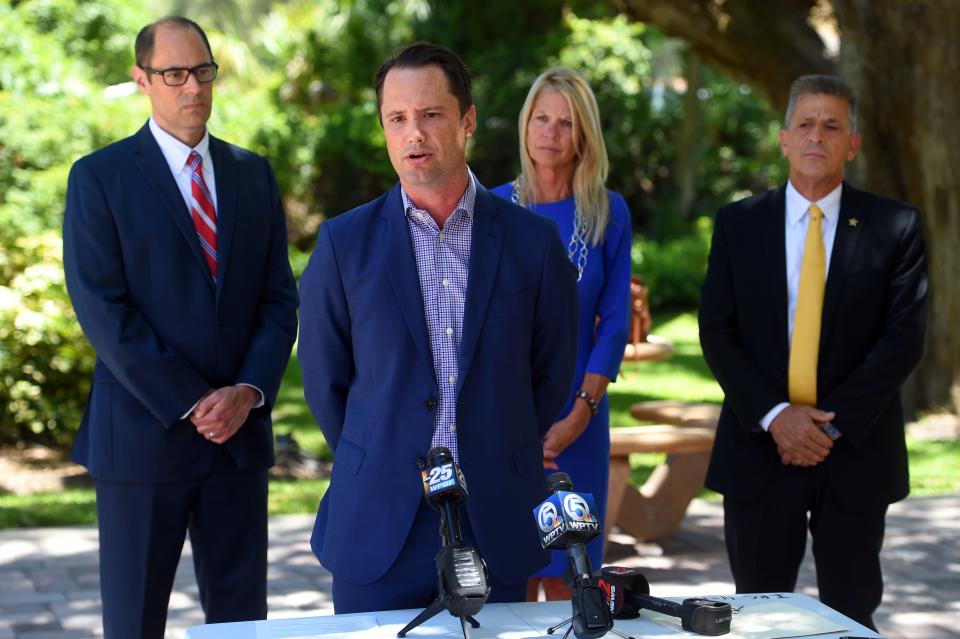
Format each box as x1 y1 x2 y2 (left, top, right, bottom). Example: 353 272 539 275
533 473 613 639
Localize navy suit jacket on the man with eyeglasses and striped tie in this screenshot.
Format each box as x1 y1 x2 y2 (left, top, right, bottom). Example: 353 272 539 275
63 126 297 483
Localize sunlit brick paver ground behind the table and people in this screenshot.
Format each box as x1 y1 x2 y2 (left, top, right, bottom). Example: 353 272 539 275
0 496 960 639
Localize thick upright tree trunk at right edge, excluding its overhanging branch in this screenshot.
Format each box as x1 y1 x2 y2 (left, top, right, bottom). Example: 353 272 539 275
834 0 960 411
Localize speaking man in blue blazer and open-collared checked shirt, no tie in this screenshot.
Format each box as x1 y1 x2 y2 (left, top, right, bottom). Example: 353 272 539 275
298 43 577 613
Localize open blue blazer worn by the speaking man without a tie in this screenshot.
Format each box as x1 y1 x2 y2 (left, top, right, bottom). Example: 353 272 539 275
298 185 577 584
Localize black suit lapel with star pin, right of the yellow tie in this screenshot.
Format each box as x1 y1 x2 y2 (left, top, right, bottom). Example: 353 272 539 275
820 182 869 350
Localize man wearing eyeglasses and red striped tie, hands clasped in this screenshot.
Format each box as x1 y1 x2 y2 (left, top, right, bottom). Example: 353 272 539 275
63 17 297 639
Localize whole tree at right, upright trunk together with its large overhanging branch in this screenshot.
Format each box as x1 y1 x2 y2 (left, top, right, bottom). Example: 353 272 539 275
608 0 960 417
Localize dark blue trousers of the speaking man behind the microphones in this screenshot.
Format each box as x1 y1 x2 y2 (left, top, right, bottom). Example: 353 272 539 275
333 501 527 614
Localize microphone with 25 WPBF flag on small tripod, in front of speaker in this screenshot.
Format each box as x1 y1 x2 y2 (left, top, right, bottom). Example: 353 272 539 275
397 446 490 639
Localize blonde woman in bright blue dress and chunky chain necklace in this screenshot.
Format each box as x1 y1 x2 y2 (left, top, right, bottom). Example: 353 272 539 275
493 69 630 600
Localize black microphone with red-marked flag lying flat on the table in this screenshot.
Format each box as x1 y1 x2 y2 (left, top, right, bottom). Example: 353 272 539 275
600 566 733 637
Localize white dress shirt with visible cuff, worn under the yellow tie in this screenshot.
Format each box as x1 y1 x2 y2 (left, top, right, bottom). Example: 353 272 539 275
760 182 843 430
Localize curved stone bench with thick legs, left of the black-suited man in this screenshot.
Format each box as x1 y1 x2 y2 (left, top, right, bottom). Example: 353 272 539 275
604 402 719 541
